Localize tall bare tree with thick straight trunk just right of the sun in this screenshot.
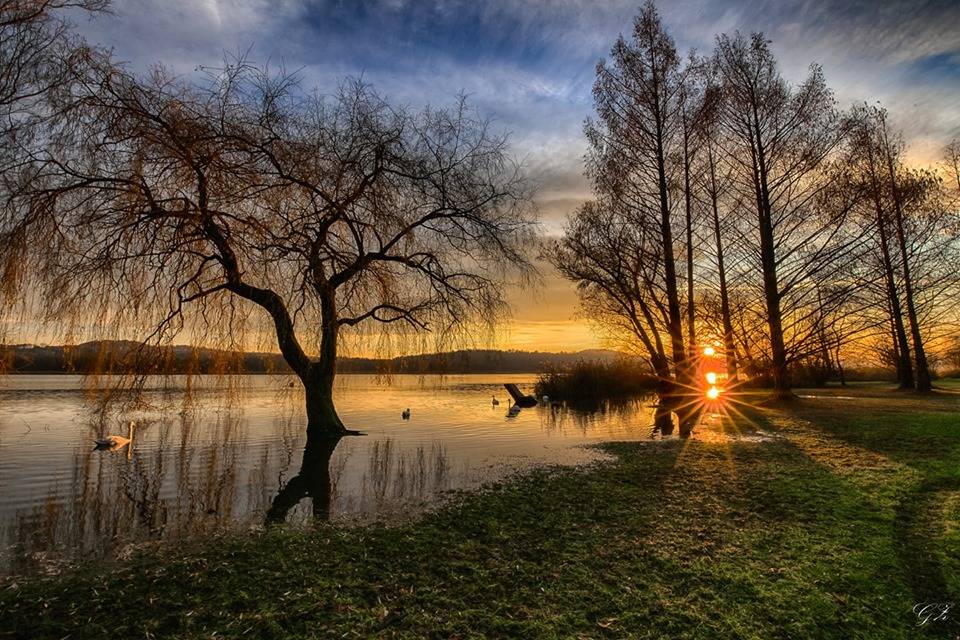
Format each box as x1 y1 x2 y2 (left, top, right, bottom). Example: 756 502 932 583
715 34 856 396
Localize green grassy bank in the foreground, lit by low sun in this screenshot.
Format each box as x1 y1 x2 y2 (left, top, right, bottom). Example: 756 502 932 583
0 389 960 639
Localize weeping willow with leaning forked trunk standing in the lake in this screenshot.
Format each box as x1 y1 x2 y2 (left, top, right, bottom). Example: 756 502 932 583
0 54 535 435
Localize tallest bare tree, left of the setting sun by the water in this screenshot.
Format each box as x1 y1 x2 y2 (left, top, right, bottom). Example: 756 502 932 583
586 1 687 380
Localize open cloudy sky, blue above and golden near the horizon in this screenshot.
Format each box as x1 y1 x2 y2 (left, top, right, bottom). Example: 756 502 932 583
69 0 960 351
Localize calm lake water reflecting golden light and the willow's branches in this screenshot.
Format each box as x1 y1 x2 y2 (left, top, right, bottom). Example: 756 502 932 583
0 375 676 575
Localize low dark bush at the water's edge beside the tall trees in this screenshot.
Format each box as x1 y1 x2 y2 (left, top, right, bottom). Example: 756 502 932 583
536 360 658 404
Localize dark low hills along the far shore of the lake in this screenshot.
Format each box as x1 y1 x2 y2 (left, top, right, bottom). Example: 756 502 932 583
0 340 625 374
